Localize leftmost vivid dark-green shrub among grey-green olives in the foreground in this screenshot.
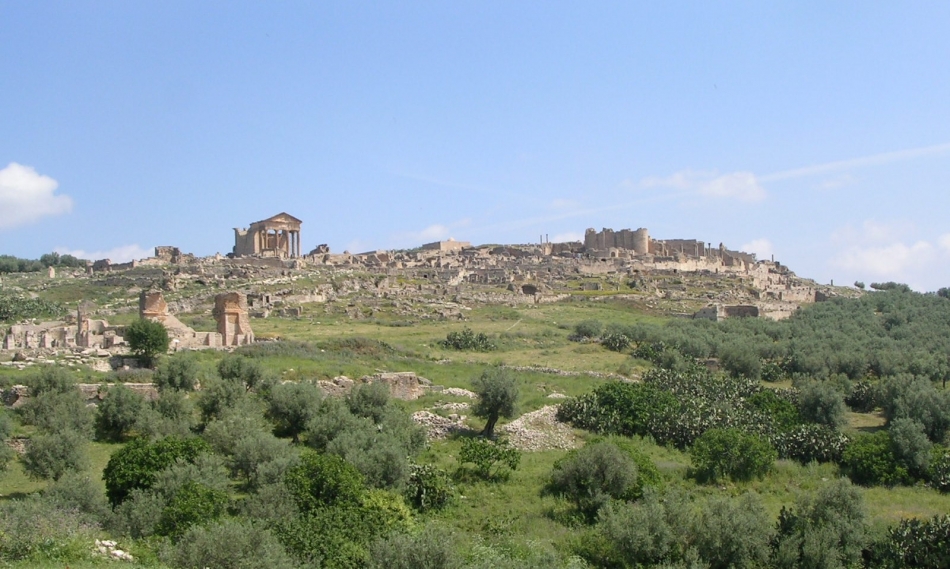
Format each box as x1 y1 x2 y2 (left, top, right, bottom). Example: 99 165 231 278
102 437 211 506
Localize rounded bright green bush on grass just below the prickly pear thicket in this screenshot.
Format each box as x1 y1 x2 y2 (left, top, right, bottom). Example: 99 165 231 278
689 429 778 482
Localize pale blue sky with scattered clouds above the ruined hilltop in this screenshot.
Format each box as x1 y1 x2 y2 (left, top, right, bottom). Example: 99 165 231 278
0 0 950 290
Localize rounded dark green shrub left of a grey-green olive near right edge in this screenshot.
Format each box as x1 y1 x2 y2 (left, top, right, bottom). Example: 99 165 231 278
841 431 911 486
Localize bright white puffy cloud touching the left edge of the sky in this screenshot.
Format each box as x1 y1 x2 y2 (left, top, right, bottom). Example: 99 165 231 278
0 162 73 229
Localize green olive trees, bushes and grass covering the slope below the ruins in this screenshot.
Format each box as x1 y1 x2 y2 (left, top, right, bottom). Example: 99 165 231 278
0 283 950 568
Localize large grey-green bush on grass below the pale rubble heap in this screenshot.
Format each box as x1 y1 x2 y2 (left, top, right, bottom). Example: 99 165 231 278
545 442 637 520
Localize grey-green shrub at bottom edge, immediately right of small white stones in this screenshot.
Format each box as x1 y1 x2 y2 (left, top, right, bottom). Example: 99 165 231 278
162 518 299 569
